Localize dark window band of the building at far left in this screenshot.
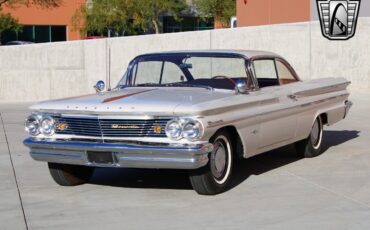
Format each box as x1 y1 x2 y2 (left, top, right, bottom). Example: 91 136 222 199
1 25 67 44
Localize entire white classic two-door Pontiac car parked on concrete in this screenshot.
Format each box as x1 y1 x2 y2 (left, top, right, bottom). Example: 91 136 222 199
24 50 352 194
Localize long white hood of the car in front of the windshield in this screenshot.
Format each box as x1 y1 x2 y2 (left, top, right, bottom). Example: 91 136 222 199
31 87 235 115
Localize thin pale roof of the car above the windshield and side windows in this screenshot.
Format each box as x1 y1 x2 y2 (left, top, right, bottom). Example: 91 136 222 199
140 49 280 59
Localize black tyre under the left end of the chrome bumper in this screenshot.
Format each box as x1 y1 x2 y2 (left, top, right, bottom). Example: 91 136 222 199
48 163 94 186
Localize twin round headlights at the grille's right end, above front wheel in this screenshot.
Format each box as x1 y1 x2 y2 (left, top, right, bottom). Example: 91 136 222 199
166 118 204 141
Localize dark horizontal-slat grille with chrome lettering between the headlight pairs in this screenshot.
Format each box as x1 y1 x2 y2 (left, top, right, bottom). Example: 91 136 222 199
54 116 171 138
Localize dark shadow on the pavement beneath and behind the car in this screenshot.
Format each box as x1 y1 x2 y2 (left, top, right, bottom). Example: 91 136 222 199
90 130 359 190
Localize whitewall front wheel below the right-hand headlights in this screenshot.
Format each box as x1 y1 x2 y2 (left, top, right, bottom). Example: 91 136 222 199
190 131 233 195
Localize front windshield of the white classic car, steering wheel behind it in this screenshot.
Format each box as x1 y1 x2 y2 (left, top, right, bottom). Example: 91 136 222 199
119 54 251 90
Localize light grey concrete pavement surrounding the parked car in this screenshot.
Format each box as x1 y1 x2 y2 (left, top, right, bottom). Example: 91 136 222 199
0 94 370 230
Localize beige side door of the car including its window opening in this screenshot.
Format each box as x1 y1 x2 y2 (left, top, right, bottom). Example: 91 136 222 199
252 59 297 150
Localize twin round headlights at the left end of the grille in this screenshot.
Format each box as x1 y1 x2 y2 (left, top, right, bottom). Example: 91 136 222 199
24 114 55 136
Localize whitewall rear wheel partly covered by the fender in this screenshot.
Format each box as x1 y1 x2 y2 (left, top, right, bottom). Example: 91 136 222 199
295 116 323 158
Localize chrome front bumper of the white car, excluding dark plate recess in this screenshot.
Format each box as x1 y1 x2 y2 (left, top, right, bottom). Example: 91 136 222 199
23 138 213 169
